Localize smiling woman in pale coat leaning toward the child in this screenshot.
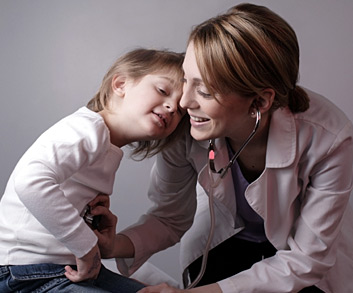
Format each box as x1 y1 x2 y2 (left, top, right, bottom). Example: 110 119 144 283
93 4 353 293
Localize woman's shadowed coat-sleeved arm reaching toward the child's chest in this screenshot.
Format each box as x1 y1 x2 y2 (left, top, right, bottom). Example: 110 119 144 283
117 133 199 275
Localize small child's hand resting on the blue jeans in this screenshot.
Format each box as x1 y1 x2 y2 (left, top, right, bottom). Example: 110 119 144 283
65 245 101 283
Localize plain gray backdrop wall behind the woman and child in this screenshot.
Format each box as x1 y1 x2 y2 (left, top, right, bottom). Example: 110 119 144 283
0 0 353 280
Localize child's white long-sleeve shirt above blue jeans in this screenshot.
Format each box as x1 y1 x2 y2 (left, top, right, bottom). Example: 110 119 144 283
0 107 123 265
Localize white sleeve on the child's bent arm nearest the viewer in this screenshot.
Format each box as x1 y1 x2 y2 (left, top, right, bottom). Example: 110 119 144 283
14 109 109 258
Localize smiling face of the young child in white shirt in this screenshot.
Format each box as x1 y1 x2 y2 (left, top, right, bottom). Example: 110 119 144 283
109 71 186 145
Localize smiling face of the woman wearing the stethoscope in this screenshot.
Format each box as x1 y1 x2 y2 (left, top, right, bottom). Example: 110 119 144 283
180 43 254 140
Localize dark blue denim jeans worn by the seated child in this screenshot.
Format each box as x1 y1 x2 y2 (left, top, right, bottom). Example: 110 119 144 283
0 264 144 293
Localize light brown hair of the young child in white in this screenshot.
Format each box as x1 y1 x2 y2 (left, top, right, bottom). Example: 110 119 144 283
87 48 186 160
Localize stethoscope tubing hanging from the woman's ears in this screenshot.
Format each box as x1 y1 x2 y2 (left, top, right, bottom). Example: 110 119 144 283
186 107 261 289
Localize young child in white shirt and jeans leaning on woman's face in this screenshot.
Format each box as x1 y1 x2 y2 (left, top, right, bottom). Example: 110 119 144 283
0 49 184 292
